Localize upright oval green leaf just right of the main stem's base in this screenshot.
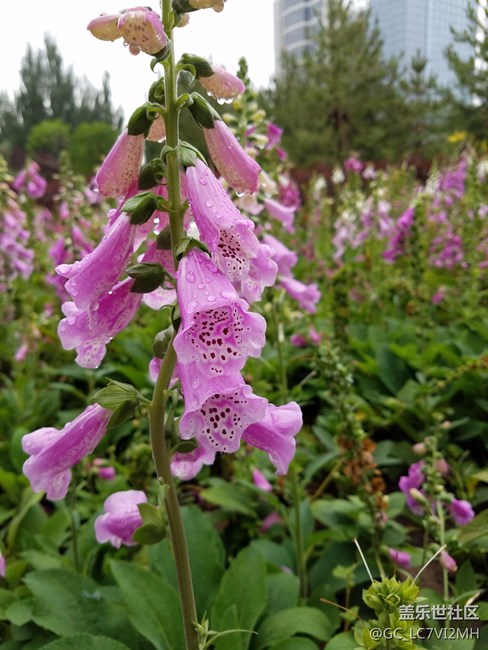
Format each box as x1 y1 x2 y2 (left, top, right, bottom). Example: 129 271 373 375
210 547 267 650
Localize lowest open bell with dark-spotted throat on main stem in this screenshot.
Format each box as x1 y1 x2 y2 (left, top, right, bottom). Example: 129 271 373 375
179 378 268 453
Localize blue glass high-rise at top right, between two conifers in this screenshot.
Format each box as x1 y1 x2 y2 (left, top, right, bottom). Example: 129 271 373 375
370 0 471 87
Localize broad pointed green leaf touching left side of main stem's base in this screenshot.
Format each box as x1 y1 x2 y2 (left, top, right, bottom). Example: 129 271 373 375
110 560 184 650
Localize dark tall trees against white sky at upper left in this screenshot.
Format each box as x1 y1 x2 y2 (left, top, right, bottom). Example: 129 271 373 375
0 35 122 167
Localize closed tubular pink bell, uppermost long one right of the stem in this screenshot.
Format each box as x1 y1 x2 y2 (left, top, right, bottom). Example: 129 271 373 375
203 120 261 193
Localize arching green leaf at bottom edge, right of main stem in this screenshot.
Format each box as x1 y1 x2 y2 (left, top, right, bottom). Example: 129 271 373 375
256 607 333 650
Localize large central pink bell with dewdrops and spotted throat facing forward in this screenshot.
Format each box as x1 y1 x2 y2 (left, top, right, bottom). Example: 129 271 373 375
174 249 266 410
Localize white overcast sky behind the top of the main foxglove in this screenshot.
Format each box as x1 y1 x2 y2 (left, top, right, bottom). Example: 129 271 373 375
0 0 274 118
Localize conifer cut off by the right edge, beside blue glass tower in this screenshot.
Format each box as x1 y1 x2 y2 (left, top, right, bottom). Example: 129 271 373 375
446 0 488 140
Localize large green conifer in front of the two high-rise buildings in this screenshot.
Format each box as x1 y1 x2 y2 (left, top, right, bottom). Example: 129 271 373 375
265 0 405 165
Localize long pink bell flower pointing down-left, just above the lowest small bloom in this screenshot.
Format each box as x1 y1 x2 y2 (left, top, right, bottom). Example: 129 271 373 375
22 404 112 501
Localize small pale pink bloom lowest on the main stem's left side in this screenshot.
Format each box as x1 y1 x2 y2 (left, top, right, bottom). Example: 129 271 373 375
95 490 147 548
